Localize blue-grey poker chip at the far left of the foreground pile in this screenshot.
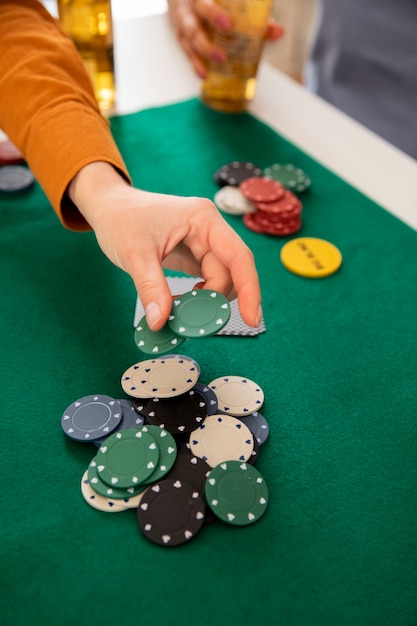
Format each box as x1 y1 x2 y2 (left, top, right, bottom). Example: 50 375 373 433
61 395 122 442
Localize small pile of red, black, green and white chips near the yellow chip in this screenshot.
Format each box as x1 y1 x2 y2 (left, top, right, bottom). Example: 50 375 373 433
214 161 311 237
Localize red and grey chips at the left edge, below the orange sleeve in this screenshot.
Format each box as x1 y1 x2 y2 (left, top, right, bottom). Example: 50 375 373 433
0 131 35 193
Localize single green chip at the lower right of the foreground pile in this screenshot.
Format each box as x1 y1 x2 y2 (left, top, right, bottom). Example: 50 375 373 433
205 461 268 526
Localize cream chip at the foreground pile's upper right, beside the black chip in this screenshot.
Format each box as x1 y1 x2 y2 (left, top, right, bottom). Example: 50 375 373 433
209 376 264 417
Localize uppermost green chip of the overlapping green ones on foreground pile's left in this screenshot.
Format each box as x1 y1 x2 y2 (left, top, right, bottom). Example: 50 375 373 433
97 427 159 489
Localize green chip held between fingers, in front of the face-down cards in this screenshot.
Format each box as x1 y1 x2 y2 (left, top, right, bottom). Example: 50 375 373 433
168 289 230 338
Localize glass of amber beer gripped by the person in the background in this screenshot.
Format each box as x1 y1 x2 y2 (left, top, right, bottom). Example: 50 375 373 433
201 0 273 113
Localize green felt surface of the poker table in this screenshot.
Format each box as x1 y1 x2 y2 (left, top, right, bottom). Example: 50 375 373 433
0 99 417 626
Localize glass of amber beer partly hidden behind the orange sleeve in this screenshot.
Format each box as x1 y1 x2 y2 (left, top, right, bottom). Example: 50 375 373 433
58 0 116 113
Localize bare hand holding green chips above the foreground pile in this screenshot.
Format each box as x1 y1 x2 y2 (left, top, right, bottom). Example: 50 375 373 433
68 162 262 330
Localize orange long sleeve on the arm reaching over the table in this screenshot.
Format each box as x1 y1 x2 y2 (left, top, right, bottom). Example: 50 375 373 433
0 0 130 230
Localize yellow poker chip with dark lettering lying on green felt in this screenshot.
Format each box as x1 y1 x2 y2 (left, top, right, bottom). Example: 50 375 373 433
281 237 342 278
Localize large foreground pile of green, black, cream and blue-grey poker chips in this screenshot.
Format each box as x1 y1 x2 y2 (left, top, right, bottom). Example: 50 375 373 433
61 354 269 546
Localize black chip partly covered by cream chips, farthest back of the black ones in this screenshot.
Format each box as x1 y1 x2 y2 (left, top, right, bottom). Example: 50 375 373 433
145 388 207 434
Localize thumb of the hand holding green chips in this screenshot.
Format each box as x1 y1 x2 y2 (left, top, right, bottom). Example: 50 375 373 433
129 248 172 330
